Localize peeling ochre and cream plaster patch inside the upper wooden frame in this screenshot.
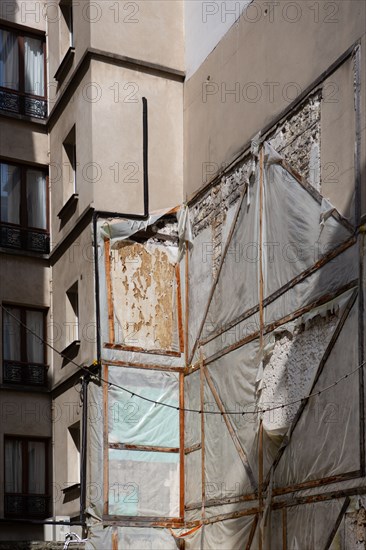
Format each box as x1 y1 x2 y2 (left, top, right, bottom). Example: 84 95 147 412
111 241 177 351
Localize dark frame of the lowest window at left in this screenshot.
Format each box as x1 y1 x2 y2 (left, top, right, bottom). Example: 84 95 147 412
3 433 50 517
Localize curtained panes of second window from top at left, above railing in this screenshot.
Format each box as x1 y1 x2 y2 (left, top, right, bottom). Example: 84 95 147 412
0 163 48 231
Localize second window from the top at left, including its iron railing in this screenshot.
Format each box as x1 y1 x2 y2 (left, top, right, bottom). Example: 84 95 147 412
0 163 49 254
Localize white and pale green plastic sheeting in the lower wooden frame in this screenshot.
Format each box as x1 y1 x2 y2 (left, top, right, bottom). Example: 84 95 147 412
108 366 180 517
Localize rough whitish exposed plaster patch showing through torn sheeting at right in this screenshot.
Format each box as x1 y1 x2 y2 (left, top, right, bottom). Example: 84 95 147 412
260 315 338 433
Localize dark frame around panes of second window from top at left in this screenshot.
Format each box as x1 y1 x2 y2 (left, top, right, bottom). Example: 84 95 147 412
0 161 50 235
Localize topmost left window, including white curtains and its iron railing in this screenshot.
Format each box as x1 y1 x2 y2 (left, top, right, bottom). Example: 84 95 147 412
0 28 47 118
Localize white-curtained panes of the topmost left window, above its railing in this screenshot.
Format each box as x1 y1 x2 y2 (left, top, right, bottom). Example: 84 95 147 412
0 28 46 97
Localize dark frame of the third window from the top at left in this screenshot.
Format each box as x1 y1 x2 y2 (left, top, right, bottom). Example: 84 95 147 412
1 302 49 387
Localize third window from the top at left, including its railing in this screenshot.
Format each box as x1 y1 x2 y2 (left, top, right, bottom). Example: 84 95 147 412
3 306 47 386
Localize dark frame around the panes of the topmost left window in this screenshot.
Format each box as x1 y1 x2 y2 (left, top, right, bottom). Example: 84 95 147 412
0 20 48 102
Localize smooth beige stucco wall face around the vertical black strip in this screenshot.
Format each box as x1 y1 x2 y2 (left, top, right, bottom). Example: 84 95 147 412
91 61 183 214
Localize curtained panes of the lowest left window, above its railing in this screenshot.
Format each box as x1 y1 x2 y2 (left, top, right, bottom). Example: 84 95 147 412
4 436 47 495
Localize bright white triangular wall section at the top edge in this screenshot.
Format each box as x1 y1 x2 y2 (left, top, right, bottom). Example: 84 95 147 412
184 0 252 78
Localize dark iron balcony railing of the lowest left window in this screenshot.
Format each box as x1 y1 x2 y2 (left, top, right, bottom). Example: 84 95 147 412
4 493 50 518
